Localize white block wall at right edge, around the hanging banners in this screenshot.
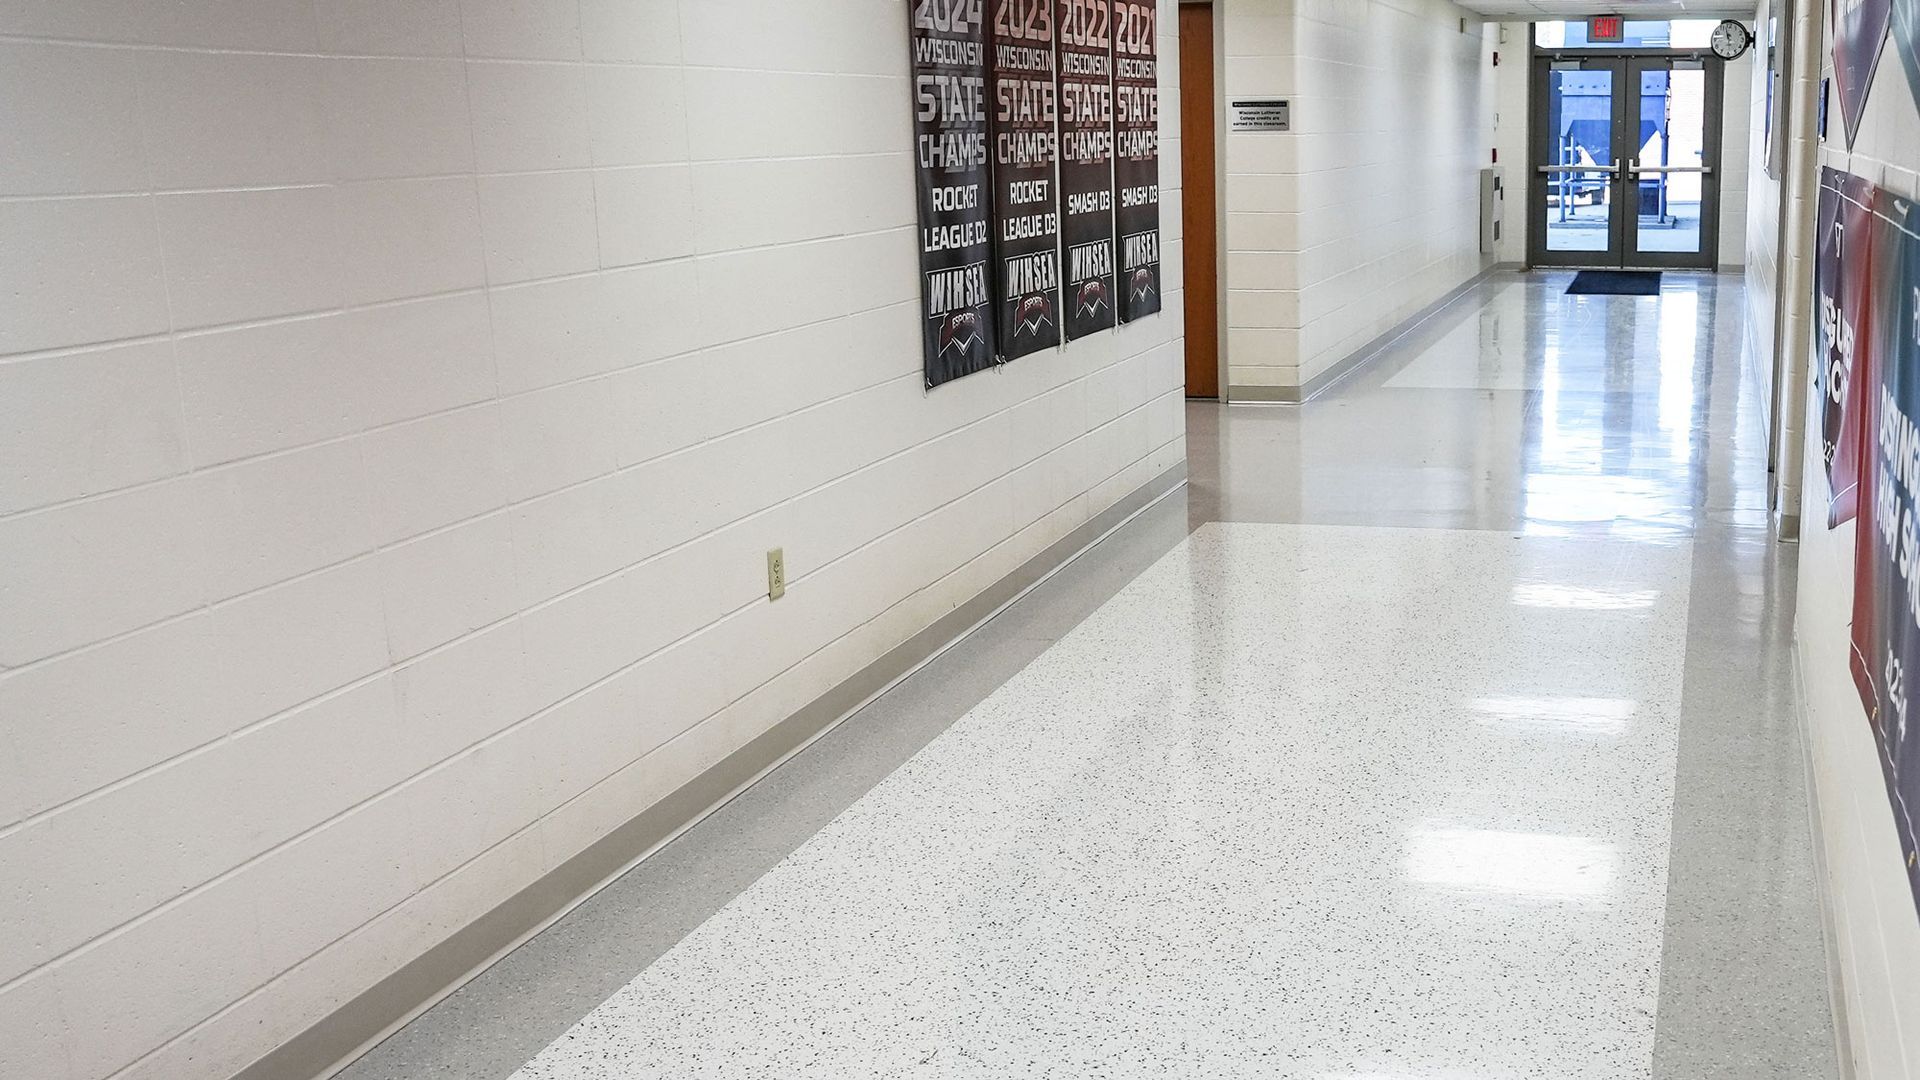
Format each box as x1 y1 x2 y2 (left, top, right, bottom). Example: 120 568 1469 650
1789 0 1920 1080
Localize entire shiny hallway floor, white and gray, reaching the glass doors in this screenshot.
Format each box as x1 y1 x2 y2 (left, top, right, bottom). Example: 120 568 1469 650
342 275 1834 1080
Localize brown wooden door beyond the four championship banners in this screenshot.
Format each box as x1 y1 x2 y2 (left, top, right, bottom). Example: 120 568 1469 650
1181 4 1219 398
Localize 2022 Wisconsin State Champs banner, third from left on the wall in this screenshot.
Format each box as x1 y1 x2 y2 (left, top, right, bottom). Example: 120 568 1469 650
1054 0 1114 340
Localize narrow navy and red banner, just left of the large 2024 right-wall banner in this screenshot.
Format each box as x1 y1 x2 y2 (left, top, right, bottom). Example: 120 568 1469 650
1812 169 1874 528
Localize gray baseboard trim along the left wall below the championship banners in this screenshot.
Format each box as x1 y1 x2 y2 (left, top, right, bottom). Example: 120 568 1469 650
234 461 1187 1080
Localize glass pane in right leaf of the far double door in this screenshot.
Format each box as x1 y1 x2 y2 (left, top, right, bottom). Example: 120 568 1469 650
1632 67 1707 252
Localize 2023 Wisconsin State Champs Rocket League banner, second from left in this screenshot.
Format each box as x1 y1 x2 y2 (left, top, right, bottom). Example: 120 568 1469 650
993 0 1060 359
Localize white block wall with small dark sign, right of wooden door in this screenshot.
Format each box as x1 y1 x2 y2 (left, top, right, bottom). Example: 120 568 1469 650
1223 0 1494 392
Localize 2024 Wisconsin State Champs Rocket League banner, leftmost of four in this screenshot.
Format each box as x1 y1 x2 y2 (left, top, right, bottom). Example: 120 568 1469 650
908 0 995 386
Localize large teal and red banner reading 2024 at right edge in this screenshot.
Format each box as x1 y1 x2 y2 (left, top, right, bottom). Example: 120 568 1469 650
1853 194 1920 905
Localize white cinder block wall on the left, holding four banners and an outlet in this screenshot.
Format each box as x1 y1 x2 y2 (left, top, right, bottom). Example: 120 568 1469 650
0 0 1185 1080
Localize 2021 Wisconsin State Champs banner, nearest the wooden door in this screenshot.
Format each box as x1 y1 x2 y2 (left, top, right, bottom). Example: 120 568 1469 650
1114 0 1160 323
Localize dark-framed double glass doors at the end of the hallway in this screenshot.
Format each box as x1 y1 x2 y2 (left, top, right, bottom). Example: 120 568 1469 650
1528 56 1724 269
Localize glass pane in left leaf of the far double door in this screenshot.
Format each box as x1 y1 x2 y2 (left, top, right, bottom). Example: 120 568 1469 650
1540 67 1613 252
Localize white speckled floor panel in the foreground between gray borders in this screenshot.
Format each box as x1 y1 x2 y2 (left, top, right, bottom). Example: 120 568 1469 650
516 525 1690 1080
